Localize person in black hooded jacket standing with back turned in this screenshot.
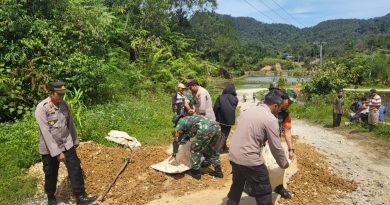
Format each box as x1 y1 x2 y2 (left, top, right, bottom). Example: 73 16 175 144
214 83 238 152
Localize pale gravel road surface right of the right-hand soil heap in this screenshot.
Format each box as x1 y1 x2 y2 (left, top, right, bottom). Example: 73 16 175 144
293 120 390 205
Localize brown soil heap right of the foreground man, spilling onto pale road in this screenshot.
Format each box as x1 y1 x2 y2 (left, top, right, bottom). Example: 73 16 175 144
280 143 358 205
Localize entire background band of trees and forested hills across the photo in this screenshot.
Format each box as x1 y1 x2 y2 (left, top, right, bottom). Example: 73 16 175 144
0 0 390 121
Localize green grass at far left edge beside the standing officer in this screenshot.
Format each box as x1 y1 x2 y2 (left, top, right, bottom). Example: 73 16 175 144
0 116 40 204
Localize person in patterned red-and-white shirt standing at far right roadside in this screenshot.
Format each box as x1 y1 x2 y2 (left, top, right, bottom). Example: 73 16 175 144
368 89 382 131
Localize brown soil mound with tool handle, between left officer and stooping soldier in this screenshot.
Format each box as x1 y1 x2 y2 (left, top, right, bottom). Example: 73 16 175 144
29 142 231 204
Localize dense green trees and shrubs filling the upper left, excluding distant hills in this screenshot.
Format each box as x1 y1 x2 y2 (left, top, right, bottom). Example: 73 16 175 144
0 0 217 121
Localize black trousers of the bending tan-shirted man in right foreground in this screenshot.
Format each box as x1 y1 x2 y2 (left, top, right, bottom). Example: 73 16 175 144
226 161 272 205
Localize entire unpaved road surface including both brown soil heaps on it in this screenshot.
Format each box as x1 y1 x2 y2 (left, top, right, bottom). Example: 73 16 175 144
27 89 390 205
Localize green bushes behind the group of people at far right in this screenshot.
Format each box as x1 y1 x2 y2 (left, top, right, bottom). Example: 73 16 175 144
303 52 390 98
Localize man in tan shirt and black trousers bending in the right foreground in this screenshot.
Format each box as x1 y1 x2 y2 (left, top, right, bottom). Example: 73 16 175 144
226 92 289 205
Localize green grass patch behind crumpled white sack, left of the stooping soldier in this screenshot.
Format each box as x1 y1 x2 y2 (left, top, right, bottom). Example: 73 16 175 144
79 94 173 145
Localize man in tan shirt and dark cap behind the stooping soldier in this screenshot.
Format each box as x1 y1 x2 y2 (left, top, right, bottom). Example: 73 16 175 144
188 79 215 121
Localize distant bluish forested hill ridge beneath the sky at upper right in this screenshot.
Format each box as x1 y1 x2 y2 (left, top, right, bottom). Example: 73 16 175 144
223 13 390 50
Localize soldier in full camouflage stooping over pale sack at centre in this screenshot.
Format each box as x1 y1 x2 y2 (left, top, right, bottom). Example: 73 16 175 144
172 115 223 180
